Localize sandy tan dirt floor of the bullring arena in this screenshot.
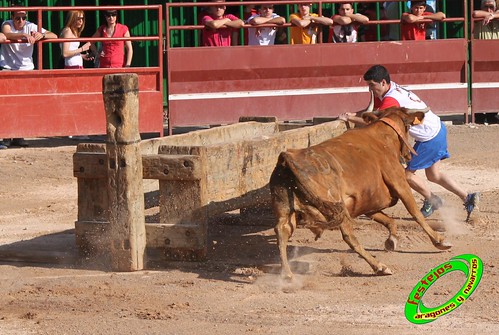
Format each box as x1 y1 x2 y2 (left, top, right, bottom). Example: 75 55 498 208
0 125 499 335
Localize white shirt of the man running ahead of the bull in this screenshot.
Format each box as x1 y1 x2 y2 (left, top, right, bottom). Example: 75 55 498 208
381 81 442 142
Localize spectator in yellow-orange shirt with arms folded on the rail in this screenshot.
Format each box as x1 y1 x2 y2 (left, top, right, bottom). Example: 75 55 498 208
289 3 333 44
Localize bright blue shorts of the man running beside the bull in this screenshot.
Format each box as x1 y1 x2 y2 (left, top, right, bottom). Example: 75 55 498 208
406 123 450 171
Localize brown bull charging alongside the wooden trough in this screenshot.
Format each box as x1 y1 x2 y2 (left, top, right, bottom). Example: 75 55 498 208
270 108 451 278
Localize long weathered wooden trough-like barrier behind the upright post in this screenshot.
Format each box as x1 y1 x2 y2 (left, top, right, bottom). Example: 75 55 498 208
73 121 346 263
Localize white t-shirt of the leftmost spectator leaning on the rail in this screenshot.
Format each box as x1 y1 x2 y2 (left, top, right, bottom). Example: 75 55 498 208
0 20 46 70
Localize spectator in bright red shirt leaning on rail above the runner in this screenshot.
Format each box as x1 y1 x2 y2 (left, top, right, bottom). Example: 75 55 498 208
400 1 445 41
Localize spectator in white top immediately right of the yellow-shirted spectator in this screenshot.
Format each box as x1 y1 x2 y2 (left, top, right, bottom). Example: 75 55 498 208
329 2 369 43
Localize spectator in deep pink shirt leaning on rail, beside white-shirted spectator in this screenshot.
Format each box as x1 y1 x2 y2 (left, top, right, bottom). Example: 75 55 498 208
201 0 244 47
